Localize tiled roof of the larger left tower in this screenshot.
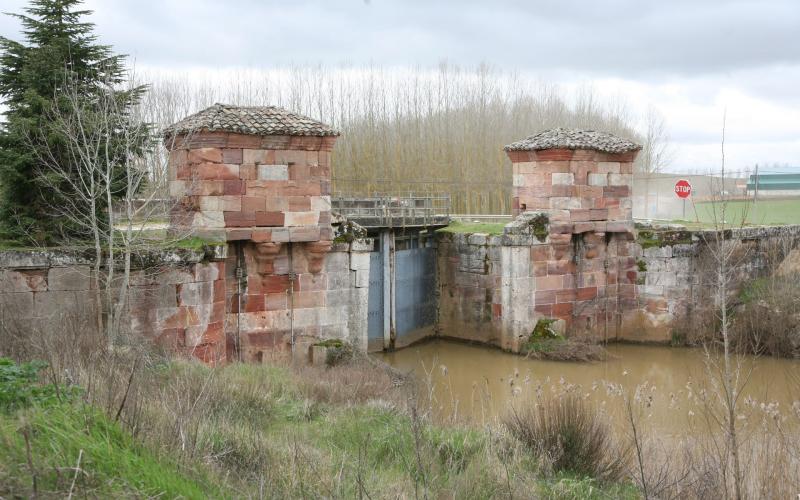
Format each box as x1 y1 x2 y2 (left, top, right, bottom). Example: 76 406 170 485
164 104 339 136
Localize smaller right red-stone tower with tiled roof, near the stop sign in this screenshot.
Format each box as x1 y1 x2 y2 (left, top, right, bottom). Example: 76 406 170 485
505 128 641 345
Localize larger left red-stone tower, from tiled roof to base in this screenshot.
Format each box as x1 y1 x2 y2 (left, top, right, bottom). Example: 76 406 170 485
165 104 369 360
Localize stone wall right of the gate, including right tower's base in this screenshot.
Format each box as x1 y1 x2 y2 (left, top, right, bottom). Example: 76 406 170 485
437 226 800 350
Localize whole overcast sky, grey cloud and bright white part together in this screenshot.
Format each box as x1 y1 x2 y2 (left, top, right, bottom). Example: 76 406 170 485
0 0 800 171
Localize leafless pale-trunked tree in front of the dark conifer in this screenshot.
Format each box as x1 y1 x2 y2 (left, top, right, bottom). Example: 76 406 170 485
31 70 194 343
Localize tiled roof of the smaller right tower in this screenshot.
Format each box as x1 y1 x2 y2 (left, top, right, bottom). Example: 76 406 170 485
505 128 642 153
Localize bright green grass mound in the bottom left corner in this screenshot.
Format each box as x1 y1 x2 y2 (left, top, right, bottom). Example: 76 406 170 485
0 403 223 498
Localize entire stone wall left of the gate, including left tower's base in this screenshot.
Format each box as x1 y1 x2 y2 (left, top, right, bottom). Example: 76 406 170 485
0 241 372 363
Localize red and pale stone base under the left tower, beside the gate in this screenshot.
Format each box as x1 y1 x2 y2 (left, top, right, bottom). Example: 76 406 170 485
219 241 371 361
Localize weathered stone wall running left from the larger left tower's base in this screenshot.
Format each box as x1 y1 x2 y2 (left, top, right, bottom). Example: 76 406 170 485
0 247 231 363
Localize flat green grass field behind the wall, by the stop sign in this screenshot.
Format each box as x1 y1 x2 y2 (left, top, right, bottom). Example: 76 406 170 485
695 198 800 226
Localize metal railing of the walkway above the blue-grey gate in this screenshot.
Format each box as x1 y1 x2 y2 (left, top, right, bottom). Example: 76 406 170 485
331 193 450 227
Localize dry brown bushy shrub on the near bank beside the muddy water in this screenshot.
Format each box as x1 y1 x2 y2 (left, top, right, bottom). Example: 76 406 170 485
503 393 630 482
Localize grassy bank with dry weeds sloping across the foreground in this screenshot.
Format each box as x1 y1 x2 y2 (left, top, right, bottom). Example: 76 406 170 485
0 354 637 498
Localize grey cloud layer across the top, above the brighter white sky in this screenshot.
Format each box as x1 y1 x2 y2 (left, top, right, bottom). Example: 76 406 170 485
0 0 800 79
